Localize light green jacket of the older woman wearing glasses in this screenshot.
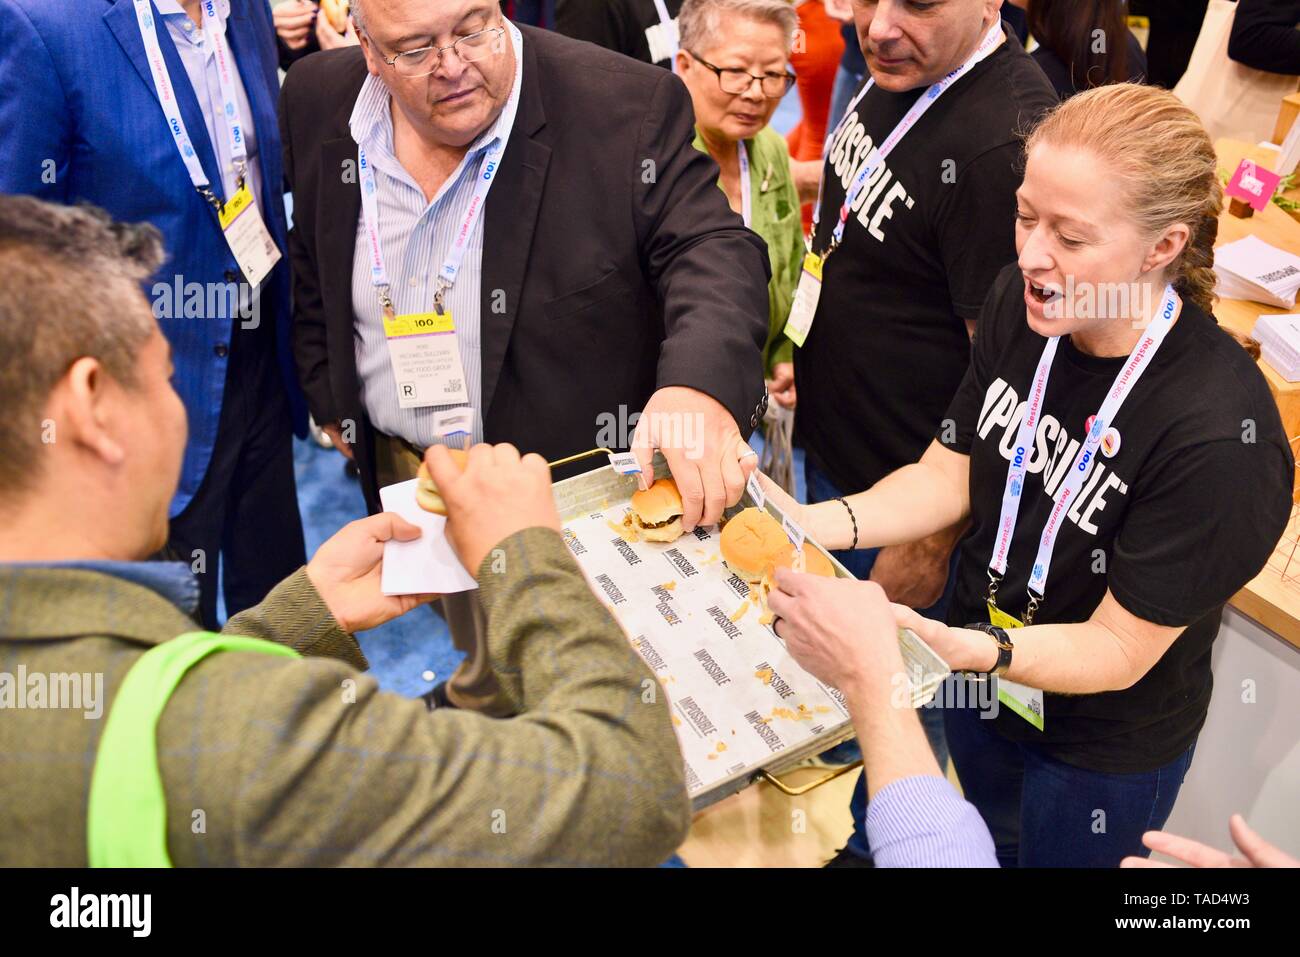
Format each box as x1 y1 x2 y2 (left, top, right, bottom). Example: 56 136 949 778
694 126 805 378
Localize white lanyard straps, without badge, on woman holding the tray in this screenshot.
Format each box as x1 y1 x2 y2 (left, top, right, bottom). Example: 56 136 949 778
988 286 1178 624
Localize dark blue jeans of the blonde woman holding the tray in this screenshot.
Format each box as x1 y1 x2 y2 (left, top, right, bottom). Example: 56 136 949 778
944 707 1196 867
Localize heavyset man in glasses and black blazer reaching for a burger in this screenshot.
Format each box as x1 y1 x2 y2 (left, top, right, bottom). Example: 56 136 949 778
281 0 768 710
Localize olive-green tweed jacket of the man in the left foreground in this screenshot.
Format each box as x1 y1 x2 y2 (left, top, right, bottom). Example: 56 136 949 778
0 528 690 866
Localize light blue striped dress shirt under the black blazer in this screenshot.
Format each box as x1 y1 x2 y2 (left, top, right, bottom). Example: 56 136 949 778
348 21 524 449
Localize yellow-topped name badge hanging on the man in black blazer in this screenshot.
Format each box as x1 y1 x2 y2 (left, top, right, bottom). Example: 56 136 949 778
384 312 469 408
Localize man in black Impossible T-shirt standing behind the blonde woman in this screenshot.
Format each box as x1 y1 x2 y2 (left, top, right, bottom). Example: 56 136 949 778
794 0 1057 866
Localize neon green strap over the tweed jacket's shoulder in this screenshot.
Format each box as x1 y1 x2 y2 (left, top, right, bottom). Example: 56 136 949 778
86 632 299 867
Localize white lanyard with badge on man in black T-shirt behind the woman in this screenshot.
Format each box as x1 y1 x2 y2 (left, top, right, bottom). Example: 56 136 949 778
785 20 1004 347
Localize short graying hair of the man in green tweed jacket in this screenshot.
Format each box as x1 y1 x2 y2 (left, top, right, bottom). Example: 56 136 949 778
0 195 163 495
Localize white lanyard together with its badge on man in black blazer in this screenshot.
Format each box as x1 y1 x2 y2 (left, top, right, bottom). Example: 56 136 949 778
356 21 524 408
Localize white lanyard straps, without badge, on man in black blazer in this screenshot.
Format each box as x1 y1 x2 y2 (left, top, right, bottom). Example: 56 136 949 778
356 21 524 315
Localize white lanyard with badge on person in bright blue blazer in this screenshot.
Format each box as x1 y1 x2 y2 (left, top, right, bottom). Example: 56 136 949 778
133 0 281 286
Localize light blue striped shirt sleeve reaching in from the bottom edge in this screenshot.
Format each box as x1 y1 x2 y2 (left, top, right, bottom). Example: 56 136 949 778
867 775 997 867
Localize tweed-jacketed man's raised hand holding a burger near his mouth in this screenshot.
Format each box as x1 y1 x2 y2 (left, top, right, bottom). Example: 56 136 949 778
421 443 560 573
